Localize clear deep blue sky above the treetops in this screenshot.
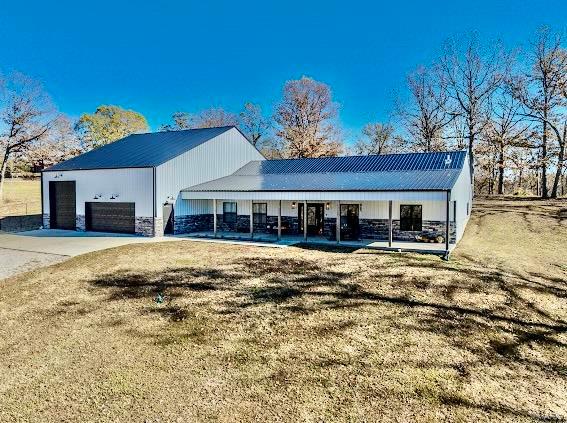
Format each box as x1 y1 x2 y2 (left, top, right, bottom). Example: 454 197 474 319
0 0 567 144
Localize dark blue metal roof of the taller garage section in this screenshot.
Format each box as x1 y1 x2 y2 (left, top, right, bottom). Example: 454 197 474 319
45 126 234 171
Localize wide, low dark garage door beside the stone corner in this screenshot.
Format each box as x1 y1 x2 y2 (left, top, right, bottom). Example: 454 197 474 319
85 202 136 234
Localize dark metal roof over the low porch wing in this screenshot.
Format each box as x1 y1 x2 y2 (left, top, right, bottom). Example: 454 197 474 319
183 151 466 192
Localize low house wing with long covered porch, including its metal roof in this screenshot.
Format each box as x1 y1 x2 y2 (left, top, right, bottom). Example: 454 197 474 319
180 151 472 253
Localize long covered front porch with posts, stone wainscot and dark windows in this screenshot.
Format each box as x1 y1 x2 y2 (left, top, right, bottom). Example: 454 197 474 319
175 191 456 255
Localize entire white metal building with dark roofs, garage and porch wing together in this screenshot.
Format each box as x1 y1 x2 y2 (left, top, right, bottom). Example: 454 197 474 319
42 127 472 253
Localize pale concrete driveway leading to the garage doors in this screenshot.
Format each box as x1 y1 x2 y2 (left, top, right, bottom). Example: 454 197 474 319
0 229 179 279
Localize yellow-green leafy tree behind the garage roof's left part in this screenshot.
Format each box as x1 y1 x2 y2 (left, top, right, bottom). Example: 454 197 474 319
75 105 149 149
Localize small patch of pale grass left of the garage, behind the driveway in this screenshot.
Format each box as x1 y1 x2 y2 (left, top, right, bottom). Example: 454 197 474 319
0 179 41 217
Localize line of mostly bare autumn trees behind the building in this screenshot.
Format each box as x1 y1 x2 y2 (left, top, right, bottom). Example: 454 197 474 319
0 28 567 198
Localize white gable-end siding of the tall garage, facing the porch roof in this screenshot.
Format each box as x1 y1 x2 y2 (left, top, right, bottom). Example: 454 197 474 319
156 128 264 217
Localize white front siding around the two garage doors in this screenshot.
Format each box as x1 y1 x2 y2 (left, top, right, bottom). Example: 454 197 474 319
43 168 153 217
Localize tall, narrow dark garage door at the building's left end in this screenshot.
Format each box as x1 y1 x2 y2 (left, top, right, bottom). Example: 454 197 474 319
49 181 76 230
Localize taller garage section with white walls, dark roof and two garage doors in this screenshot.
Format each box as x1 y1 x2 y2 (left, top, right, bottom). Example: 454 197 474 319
41 126 264 236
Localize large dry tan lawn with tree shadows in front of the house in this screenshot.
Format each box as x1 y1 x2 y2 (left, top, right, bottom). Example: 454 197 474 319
0 201 567 422
